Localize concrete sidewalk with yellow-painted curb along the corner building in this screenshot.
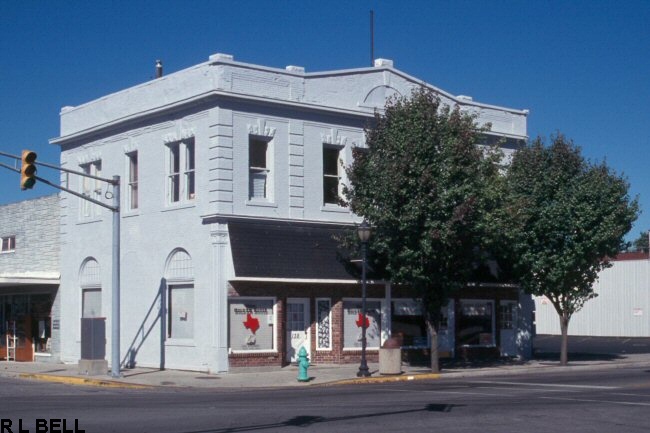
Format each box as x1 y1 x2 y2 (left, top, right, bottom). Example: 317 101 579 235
0 354 650 389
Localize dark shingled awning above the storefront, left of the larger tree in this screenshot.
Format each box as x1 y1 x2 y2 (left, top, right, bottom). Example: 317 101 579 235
228 221 355 280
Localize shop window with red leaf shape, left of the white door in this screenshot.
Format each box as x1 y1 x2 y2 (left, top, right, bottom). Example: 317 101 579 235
228 299 275 351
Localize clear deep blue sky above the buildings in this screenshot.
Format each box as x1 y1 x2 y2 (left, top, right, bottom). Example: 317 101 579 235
0 0 650 237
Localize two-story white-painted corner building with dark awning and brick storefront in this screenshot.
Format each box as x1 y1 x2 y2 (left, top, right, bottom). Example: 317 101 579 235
52 54 529 372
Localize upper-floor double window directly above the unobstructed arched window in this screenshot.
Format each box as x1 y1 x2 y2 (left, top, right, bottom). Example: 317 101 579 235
167 139 195 203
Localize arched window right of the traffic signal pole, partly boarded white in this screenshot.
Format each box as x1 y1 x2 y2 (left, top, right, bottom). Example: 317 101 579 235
165 249 194 339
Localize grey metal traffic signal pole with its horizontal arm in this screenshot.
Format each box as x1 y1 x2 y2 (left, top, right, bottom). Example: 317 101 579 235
0 151 120 377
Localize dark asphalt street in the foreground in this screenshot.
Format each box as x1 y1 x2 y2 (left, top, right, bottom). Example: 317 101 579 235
0 368 650 433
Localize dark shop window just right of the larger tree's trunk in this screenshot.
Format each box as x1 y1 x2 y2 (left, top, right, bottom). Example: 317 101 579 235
456 300 495 346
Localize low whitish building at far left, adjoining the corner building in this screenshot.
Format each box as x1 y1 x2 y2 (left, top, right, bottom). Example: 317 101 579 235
0 194 60 362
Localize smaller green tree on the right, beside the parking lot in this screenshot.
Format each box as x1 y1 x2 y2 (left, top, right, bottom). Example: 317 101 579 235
503 134 638 365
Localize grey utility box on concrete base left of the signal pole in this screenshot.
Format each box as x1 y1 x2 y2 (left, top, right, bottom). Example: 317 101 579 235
79 317 108 376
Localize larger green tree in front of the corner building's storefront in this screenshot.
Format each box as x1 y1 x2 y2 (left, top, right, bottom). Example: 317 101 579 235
344 90 498 371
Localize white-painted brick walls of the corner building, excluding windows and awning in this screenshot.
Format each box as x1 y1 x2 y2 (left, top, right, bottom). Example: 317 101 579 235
53 54 527 372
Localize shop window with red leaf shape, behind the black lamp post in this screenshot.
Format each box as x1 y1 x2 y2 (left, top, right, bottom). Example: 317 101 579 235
343 301 381 349
